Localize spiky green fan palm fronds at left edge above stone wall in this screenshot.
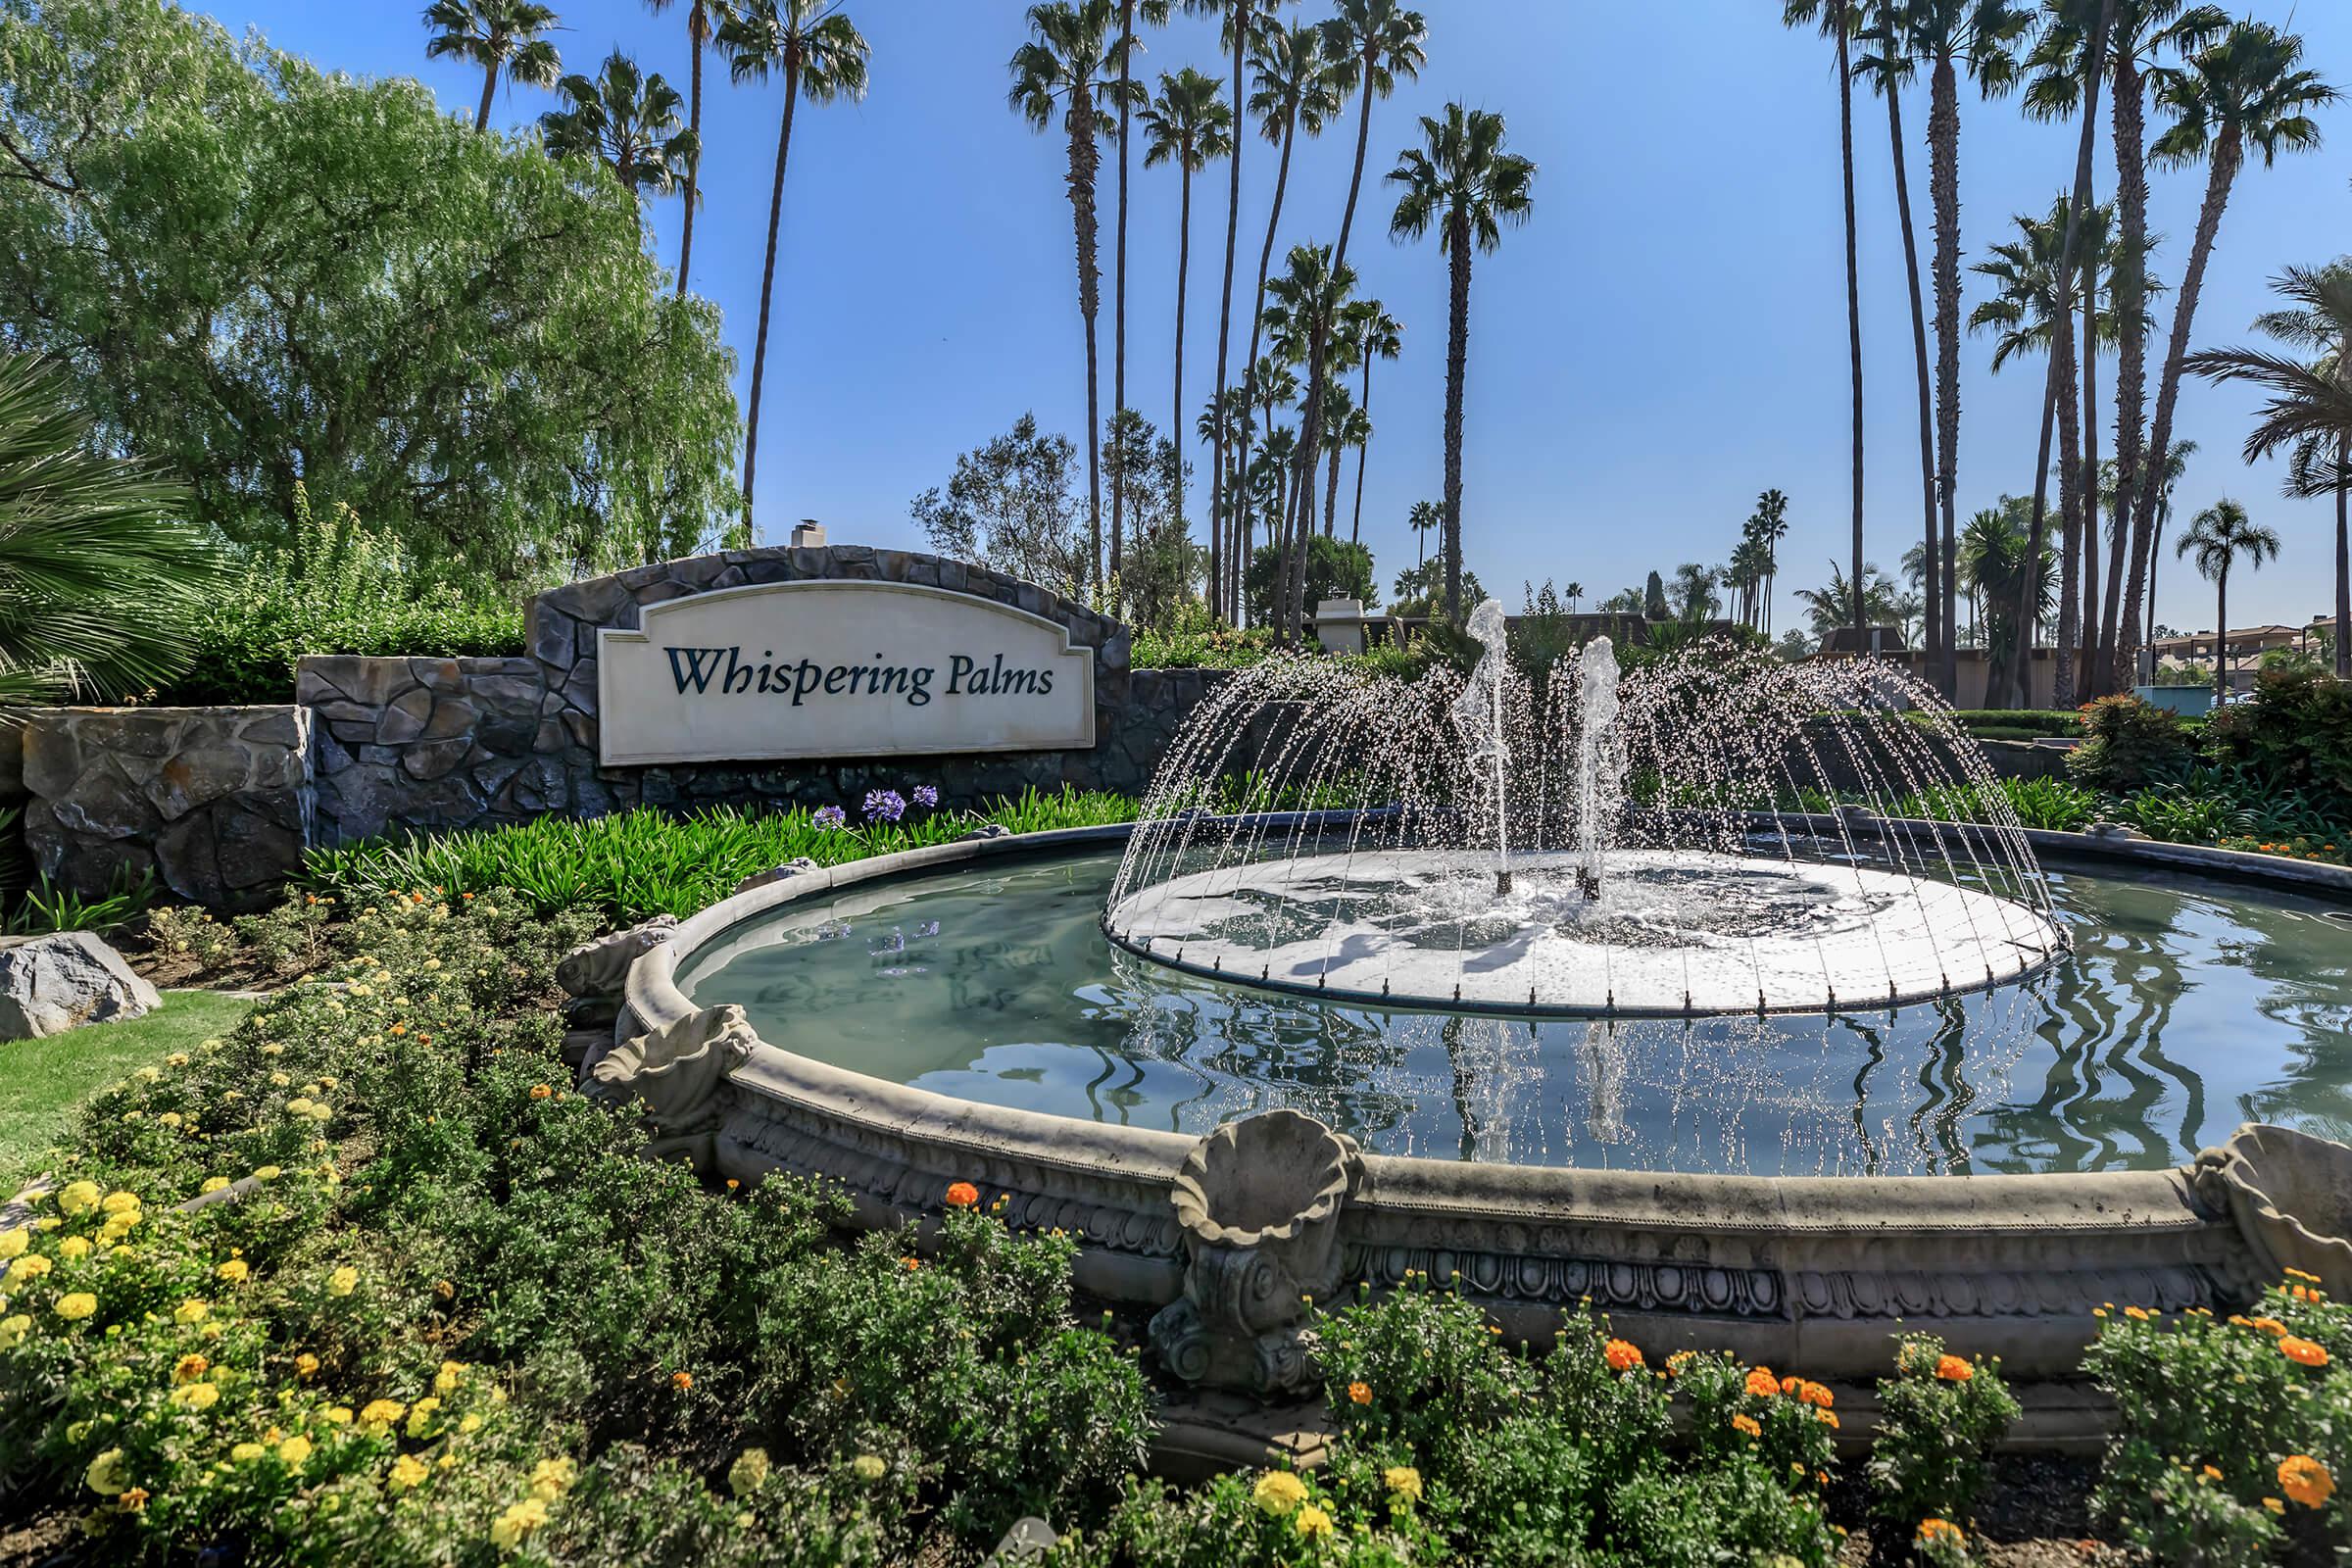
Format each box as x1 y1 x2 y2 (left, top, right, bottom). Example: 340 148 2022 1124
0 355 219 705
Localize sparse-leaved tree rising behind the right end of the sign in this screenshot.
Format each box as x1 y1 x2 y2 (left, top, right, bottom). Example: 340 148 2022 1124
910 414 1087 600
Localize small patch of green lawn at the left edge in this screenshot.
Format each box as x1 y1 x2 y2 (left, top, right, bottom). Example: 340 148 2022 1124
0 992 254 1199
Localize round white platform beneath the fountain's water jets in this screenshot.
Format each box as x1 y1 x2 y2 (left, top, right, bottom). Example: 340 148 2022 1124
1103 849 2065 1018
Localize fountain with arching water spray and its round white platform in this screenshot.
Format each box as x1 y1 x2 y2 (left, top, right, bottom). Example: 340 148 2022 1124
1103 600 2065 1018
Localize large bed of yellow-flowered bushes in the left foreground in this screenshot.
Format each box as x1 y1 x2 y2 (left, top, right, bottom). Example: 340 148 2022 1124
0 891 1146 1566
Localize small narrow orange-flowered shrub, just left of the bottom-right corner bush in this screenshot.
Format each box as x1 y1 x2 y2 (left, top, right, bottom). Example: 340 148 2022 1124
1870 1333 2018 1538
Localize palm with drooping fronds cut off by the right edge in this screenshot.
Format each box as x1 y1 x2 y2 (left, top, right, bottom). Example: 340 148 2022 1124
2187 261 2352 679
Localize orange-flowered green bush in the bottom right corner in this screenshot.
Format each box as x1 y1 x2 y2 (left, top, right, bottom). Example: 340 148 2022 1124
2086 1274 2352 1568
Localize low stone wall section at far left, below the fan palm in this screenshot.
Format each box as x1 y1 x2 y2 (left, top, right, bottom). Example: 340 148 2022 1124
22 708 316 907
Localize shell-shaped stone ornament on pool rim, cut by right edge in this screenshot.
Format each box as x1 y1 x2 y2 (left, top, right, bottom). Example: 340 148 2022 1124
2194 1121 2352 1296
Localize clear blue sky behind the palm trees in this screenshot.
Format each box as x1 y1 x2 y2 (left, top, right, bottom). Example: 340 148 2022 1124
198 0 2352 627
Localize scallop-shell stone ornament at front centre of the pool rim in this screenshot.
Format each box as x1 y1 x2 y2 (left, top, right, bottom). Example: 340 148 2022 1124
1151 1109 1364 1394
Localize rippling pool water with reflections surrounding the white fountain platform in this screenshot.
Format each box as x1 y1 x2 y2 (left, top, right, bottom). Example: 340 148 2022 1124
680 856 2352 1173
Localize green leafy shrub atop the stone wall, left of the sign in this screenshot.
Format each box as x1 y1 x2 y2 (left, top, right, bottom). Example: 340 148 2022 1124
153 482 524 706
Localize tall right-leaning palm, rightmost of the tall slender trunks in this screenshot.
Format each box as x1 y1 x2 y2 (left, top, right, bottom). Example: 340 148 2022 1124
2117 22 2340 665
